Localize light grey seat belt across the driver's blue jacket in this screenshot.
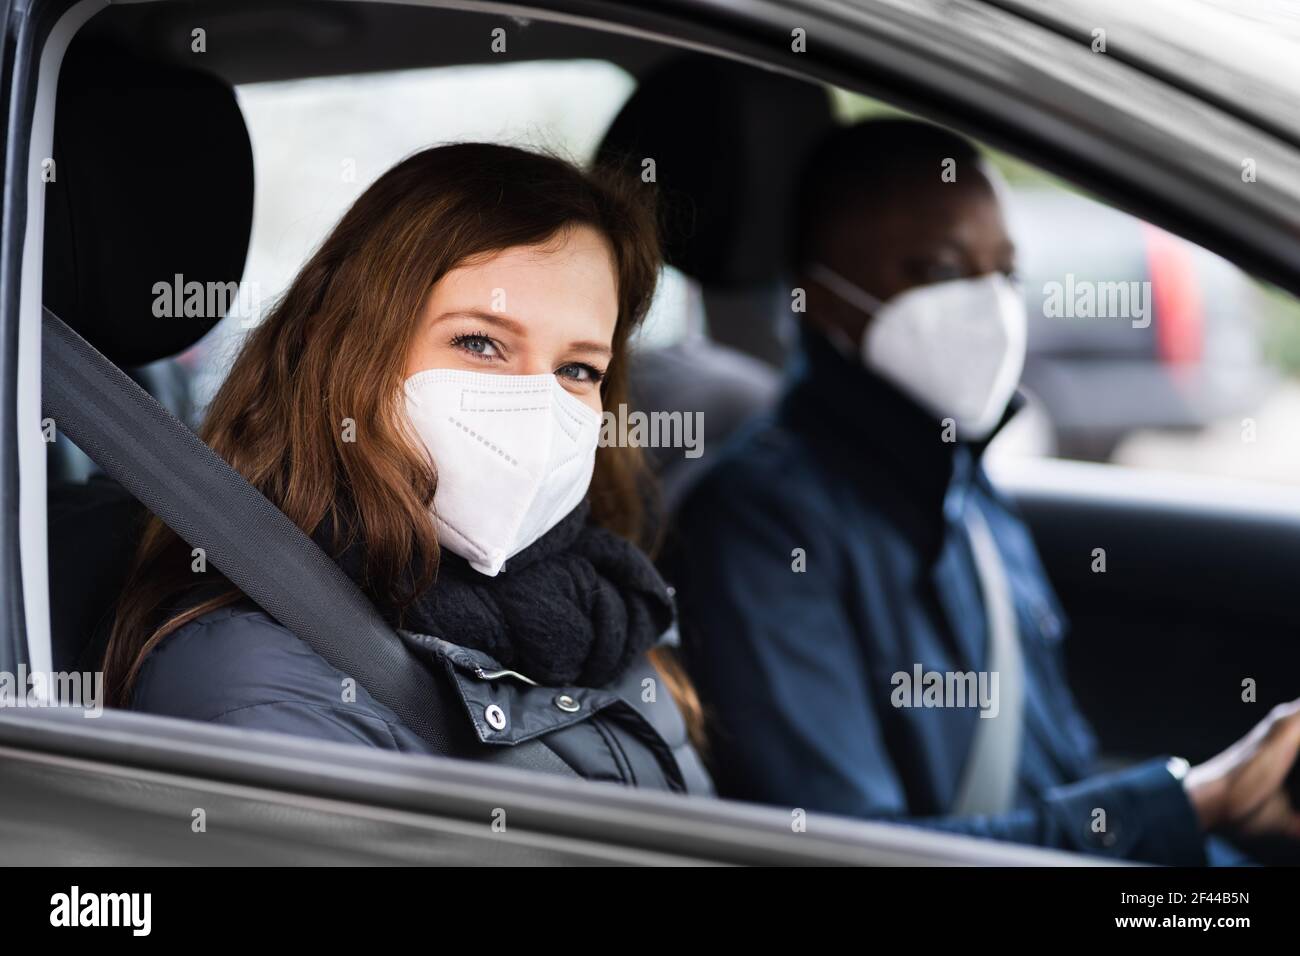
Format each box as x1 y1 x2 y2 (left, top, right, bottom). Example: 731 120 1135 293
953 499 1024 817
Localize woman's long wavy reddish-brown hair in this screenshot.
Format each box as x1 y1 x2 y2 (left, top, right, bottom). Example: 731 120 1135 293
104 143 702 743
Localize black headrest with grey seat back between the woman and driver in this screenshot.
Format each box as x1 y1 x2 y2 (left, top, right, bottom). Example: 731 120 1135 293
598 55 832 511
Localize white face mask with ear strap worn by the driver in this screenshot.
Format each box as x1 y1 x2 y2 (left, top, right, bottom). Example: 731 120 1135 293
807 263 1028 441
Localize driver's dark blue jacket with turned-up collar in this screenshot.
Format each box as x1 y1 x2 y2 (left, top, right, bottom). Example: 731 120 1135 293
670 332 1205 865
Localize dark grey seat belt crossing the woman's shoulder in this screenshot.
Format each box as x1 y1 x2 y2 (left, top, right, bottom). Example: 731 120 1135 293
40 308 465 756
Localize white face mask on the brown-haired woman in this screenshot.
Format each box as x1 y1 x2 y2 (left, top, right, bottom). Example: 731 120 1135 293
406 368 601 576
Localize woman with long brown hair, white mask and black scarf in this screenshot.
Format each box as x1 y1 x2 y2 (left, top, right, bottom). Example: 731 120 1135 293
105 143 709 790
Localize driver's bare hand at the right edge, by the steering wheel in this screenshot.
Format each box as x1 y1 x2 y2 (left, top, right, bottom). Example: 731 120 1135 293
1184 700 1300 840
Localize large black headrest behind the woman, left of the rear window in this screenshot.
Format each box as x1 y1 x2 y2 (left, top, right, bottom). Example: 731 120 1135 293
44 36 252 365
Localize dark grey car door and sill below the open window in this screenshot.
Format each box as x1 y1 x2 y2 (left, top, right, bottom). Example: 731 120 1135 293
0 708 1113 866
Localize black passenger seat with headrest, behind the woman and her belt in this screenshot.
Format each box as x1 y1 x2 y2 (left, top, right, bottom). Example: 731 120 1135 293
43 34 254 669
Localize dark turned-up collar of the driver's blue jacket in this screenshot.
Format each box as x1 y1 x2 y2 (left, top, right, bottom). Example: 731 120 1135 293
779 324 1024 512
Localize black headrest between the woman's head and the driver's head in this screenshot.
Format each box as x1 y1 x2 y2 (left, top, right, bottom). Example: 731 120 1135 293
597 55 832 286
